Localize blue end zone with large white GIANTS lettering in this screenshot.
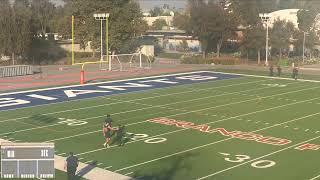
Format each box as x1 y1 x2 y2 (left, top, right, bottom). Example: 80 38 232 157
0 71 240 111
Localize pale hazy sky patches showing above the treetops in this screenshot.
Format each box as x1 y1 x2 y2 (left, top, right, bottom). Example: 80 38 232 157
51 0 188 11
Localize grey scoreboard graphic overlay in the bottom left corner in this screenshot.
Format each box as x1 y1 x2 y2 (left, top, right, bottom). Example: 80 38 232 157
1 142 55 178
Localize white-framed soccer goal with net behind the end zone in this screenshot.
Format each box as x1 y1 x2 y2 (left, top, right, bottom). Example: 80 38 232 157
104 53 152 71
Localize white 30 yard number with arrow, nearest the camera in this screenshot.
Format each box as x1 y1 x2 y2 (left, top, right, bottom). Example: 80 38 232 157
220 153 276 169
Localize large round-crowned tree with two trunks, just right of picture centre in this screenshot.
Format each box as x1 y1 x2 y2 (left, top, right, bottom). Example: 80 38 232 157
187 0 238 58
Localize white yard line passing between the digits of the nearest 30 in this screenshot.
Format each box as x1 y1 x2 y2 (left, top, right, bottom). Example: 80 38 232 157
198 116 320 180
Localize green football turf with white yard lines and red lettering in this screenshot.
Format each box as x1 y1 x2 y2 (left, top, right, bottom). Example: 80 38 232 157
0 73 320 180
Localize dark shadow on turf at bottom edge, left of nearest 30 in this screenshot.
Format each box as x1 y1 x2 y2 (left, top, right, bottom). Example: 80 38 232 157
132 153 198 180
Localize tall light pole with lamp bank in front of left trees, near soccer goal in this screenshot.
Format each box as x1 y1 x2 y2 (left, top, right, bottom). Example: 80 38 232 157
93 13 109 65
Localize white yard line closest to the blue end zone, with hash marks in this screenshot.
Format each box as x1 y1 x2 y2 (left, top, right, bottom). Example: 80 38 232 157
0 80 267 123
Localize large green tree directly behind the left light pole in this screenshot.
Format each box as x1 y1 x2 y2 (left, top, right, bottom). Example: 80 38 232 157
67 0 142 55
